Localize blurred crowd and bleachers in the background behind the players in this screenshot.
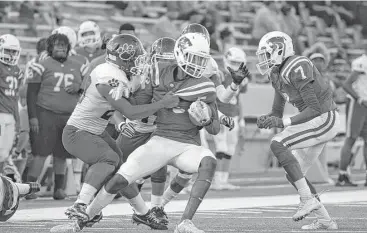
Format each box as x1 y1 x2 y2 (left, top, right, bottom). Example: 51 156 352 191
0 1 367 199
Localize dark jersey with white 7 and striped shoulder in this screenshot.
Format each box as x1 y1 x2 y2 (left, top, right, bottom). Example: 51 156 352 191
272 55 336 113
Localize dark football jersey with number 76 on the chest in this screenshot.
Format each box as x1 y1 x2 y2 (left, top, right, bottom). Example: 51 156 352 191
27 55 88 114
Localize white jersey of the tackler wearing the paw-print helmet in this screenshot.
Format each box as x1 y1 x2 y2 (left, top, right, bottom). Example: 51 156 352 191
67 63 130 135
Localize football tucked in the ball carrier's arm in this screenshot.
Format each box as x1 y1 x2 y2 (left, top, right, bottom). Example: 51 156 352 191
188 100 212 126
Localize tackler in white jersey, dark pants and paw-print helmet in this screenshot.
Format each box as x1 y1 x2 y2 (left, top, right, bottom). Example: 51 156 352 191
51 34 178 232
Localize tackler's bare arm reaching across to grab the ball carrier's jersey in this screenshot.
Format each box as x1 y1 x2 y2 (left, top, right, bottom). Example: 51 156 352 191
97 84 179 120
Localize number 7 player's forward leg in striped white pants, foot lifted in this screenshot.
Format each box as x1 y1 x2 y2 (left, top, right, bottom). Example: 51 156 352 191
270 111 339 221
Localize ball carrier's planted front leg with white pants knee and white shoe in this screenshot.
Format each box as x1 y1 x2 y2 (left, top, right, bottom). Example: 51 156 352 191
171 145 217 233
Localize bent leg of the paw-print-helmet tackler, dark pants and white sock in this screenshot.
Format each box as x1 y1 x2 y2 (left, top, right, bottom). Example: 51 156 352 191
62 125 121 220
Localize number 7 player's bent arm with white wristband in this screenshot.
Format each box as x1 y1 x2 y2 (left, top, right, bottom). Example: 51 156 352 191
283 62 321 126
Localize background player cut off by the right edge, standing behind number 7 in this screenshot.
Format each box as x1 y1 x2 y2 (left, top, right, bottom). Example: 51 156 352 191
336 54 367 187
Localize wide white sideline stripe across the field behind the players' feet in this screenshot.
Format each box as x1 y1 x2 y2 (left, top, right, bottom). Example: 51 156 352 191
11 190 367 222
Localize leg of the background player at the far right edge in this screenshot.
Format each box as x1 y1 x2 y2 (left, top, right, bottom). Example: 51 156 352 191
336 98 367 187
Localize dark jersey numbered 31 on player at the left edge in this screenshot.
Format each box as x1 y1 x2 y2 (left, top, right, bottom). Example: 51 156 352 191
0 62 23 119
